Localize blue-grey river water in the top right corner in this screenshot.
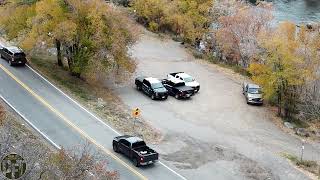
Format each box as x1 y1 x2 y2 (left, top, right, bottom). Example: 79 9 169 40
269 0 320 24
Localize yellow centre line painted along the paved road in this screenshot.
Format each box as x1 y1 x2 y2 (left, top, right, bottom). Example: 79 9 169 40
0 64 148 180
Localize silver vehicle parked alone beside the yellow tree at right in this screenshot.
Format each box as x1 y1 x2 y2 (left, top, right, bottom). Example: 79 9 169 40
242 83 263 104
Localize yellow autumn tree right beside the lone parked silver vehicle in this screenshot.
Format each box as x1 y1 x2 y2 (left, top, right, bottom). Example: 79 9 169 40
248 22 311 117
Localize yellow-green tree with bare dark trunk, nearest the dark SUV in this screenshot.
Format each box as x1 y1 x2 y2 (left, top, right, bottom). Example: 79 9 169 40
21 0 76 66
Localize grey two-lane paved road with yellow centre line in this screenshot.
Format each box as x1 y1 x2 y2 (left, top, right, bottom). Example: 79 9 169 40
0 59 183 180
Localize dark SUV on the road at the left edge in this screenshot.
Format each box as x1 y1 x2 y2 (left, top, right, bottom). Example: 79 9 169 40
0 46 27 66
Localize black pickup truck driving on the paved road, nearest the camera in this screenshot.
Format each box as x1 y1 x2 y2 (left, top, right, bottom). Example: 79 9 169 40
112 135 159 167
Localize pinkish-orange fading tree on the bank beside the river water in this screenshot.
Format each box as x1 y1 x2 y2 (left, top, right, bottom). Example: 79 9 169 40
213 1 272 68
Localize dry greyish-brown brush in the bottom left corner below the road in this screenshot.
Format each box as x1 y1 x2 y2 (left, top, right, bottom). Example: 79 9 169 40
0 102 119 180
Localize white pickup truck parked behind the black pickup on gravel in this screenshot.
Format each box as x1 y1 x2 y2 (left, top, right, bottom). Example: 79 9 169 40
167 72 200 93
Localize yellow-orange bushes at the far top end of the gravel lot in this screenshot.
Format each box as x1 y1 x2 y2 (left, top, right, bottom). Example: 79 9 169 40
131 0 213 44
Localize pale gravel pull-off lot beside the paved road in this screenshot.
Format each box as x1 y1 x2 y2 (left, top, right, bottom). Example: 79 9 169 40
114 32 320 180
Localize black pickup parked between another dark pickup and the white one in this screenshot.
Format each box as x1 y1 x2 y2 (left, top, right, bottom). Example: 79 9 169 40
162 79 195 99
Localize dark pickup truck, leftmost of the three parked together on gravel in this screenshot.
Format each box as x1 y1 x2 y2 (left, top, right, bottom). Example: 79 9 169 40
135 77 168 100
